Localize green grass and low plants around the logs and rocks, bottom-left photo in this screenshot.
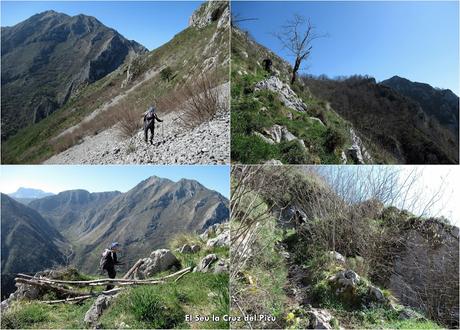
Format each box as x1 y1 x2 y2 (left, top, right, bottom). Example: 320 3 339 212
1 226 229 329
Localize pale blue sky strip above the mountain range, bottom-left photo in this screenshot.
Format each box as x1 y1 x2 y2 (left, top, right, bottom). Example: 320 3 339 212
0 165 230 198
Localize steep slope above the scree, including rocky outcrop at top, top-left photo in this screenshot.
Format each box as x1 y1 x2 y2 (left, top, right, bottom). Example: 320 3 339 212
2 1 230 163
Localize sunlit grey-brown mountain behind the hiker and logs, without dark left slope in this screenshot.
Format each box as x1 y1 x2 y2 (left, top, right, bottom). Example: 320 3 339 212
27 177 229 273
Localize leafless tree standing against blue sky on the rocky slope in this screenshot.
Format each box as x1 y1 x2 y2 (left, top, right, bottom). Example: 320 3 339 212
274 14 326 84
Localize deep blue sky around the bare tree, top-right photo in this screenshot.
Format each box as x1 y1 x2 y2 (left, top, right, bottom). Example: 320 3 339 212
232 1 459 95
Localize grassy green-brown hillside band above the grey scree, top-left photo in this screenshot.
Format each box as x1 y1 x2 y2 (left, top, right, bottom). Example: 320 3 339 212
2 6 229 163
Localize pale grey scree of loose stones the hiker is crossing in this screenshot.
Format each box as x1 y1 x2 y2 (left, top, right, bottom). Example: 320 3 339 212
44 83 230 164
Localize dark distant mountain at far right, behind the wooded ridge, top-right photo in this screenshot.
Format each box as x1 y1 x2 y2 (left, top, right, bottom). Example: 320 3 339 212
380 76 459 139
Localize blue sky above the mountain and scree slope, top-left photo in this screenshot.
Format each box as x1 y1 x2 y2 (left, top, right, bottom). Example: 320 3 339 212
1 0 203 50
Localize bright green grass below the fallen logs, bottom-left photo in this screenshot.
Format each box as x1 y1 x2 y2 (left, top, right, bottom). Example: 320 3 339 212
1 235 229 329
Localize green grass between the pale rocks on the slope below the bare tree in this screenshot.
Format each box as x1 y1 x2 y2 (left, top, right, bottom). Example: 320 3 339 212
231 29 391 164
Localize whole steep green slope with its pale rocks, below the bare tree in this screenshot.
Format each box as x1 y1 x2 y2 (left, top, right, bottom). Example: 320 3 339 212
231 28 384 164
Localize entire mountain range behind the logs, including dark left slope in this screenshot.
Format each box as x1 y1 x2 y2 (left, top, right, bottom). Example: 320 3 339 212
1 177 229 298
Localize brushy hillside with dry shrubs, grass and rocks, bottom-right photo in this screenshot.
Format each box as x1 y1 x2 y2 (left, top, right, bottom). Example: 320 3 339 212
230 166 459 329
